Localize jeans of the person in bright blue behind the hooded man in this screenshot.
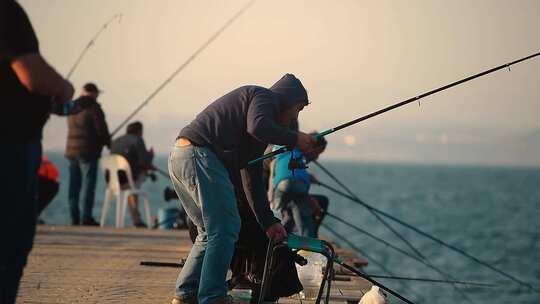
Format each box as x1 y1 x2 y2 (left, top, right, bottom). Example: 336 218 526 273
272 179 317 238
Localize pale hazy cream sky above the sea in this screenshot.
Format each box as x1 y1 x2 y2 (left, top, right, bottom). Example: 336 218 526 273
20 0 540 165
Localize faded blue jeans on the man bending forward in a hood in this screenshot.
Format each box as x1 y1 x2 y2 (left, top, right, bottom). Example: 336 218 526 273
169 145 240 304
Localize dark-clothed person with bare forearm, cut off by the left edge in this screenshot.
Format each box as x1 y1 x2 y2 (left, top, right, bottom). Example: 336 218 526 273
0 0 73 304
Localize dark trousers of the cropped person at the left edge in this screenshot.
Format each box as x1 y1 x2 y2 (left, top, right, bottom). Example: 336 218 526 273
0 140 41 304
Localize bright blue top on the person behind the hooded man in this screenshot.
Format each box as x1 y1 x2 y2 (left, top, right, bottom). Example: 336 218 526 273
272 146 311 188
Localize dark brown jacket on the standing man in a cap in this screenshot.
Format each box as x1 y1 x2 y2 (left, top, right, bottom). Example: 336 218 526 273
66 96 111 159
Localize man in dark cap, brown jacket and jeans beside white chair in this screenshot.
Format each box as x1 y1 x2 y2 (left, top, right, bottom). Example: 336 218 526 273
66 82 111 226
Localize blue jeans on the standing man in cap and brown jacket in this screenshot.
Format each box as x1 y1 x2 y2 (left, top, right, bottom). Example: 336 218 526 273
68 158 98 225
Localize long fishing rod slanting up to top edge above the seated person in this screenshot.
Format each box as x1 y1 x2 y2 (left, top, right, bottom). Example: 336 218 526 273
111 0 255 137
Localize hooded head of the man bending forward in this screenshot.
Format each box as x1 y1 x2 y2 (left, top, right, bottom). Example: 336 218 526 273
270 74 309 126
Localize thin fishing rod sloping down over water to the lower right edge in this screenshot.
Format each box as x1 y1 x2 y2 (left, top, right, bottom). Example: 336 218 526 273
317 182 540 293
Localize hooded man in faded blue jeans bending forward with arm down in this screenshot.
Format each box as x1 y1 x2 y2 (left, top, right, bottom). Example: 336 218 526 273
169 74 315 304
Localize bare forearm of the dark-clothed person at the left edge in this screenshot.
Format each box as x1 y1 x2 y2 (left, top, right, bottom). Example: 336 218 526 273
11 53 74 102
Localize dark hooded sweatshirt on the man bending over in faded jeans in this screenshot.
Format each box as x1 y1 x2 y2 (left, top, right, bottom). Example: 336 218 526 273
179 74 308 229
